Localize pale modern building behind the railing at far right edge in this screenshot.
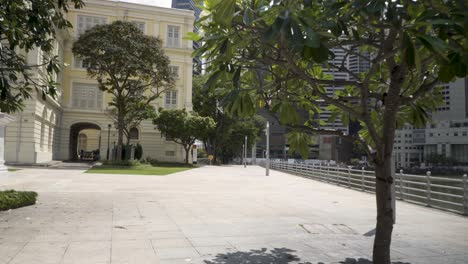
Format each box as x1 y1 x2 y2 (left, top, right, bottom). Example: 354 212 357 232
394 78 468 168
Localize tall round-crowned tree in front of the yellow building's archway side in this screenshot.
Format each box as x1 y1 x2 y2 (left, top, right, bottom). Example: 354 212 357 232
72 21 174 160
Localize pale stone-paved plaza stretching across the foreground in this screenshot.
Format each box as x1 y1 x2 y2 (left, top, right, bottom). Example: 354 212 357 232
0 166 468 264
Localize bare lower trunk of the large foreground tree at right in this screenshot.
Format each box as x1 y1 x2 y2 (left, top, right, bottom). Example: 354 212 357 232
373 156 395 264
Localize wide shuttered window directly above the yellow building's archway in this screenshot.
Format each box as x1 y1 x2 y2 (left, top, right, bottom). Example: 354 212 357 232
72 83 102 110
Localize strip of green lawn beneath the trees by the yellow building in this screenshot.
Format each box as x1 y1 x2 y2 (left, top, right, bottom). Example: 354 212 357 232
86 165 193 175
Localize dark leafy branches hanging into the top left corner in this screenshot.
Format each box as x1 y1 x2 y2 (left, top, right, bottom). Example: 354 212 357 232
0 0 83 113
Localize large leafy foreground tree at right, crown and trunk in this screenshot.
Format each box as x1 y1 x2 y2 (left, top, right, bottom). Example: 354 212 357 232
193 0 468 264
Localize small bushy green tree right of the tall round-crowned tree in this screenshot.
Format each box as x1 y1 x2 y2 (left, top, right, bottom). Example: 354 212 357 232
153 109 215 163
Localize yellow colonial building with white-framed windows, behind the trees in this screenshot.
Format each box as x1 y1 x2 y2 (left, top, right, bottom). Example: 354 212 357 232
5 0 194 164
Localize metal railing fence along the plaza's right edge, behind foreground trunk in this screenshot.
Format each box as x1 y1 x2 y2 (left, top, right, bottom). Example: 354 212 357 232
270 161 468 215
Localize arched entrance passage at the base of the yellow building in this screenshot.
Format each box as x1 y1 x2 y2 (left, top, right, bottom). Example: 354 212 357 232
69 122 101 161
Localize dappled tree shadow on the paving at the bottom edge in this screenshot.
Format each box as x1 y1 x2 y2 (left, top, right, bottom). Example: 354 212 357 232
201 248 410 264
